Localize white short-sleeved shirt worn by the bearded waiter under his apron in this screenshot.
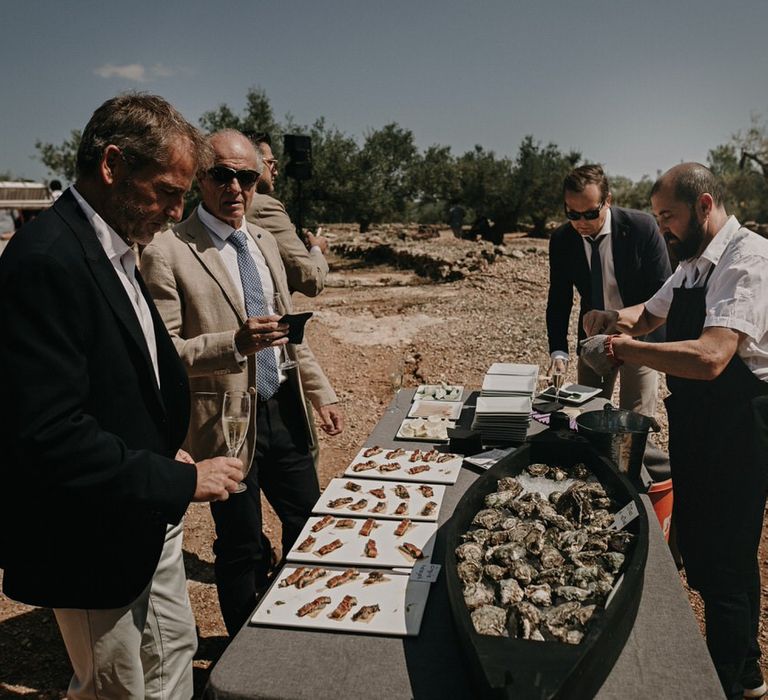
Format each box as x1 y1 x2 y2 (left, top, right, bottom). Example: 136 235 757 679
645 216 768 381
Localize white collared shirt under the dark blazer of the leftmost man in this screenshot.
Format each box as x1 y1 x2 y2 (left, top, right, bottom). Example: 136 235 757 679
69 185 160 386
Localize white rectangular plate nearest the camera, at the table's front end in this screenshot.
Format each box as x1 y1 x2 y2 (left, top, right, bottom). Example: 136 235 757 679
251 564 430 636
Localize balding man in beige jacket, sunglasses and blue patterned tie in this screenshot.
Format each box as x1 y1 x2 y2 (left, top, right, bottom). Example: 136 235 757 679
142 131 342 634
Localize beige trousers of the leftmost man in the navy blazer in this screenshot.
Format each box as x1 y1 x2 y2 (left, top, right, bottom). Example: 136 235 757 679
53 523 197 700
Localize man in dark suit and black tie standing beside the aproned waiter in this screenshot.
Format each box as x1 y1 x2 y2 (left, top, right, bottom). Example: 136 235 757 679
547 165 671 416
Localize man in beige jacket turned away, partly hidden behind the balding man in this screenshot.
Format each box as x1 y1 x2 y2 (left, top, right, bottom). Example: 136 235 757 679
246 135 328 297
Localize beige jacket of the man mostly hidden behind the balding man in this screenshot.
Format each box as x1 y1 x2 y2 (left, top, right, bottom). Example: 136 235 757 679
246 194 328 297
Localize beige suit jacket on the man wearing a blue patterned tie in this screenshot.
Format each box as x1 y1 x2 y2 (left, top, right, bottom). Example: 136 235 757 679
141 211 338 468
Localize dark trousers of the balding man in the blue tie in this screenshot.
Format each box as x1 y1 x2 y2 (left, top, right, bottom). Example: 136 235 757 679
211 383 320 636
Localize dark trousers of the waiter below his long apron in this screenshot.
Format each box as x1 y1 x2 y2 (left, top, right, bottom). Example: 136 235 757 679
700 568 760 698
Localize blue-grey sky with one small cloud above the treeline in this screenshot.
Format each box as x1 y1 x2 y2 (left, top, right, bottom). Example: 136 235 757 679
0 0 768 179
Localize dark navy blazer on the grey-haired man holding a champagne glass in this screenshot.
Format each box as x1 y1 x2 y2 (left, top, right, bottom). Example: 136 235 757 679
0 192 197 608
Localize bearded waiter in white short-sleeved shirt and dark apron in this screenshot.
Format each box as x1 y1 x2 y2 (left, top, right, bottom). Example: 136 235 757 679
582 163 768 698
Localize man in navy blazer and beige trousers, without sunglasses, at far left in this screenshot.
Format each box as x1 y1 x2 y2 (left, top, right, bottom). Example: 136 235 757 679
0 95 242 698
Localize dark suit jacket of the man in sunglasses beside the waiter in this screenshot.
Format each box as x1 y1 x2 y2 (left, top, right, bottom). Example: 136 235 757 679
547 207 672 353
